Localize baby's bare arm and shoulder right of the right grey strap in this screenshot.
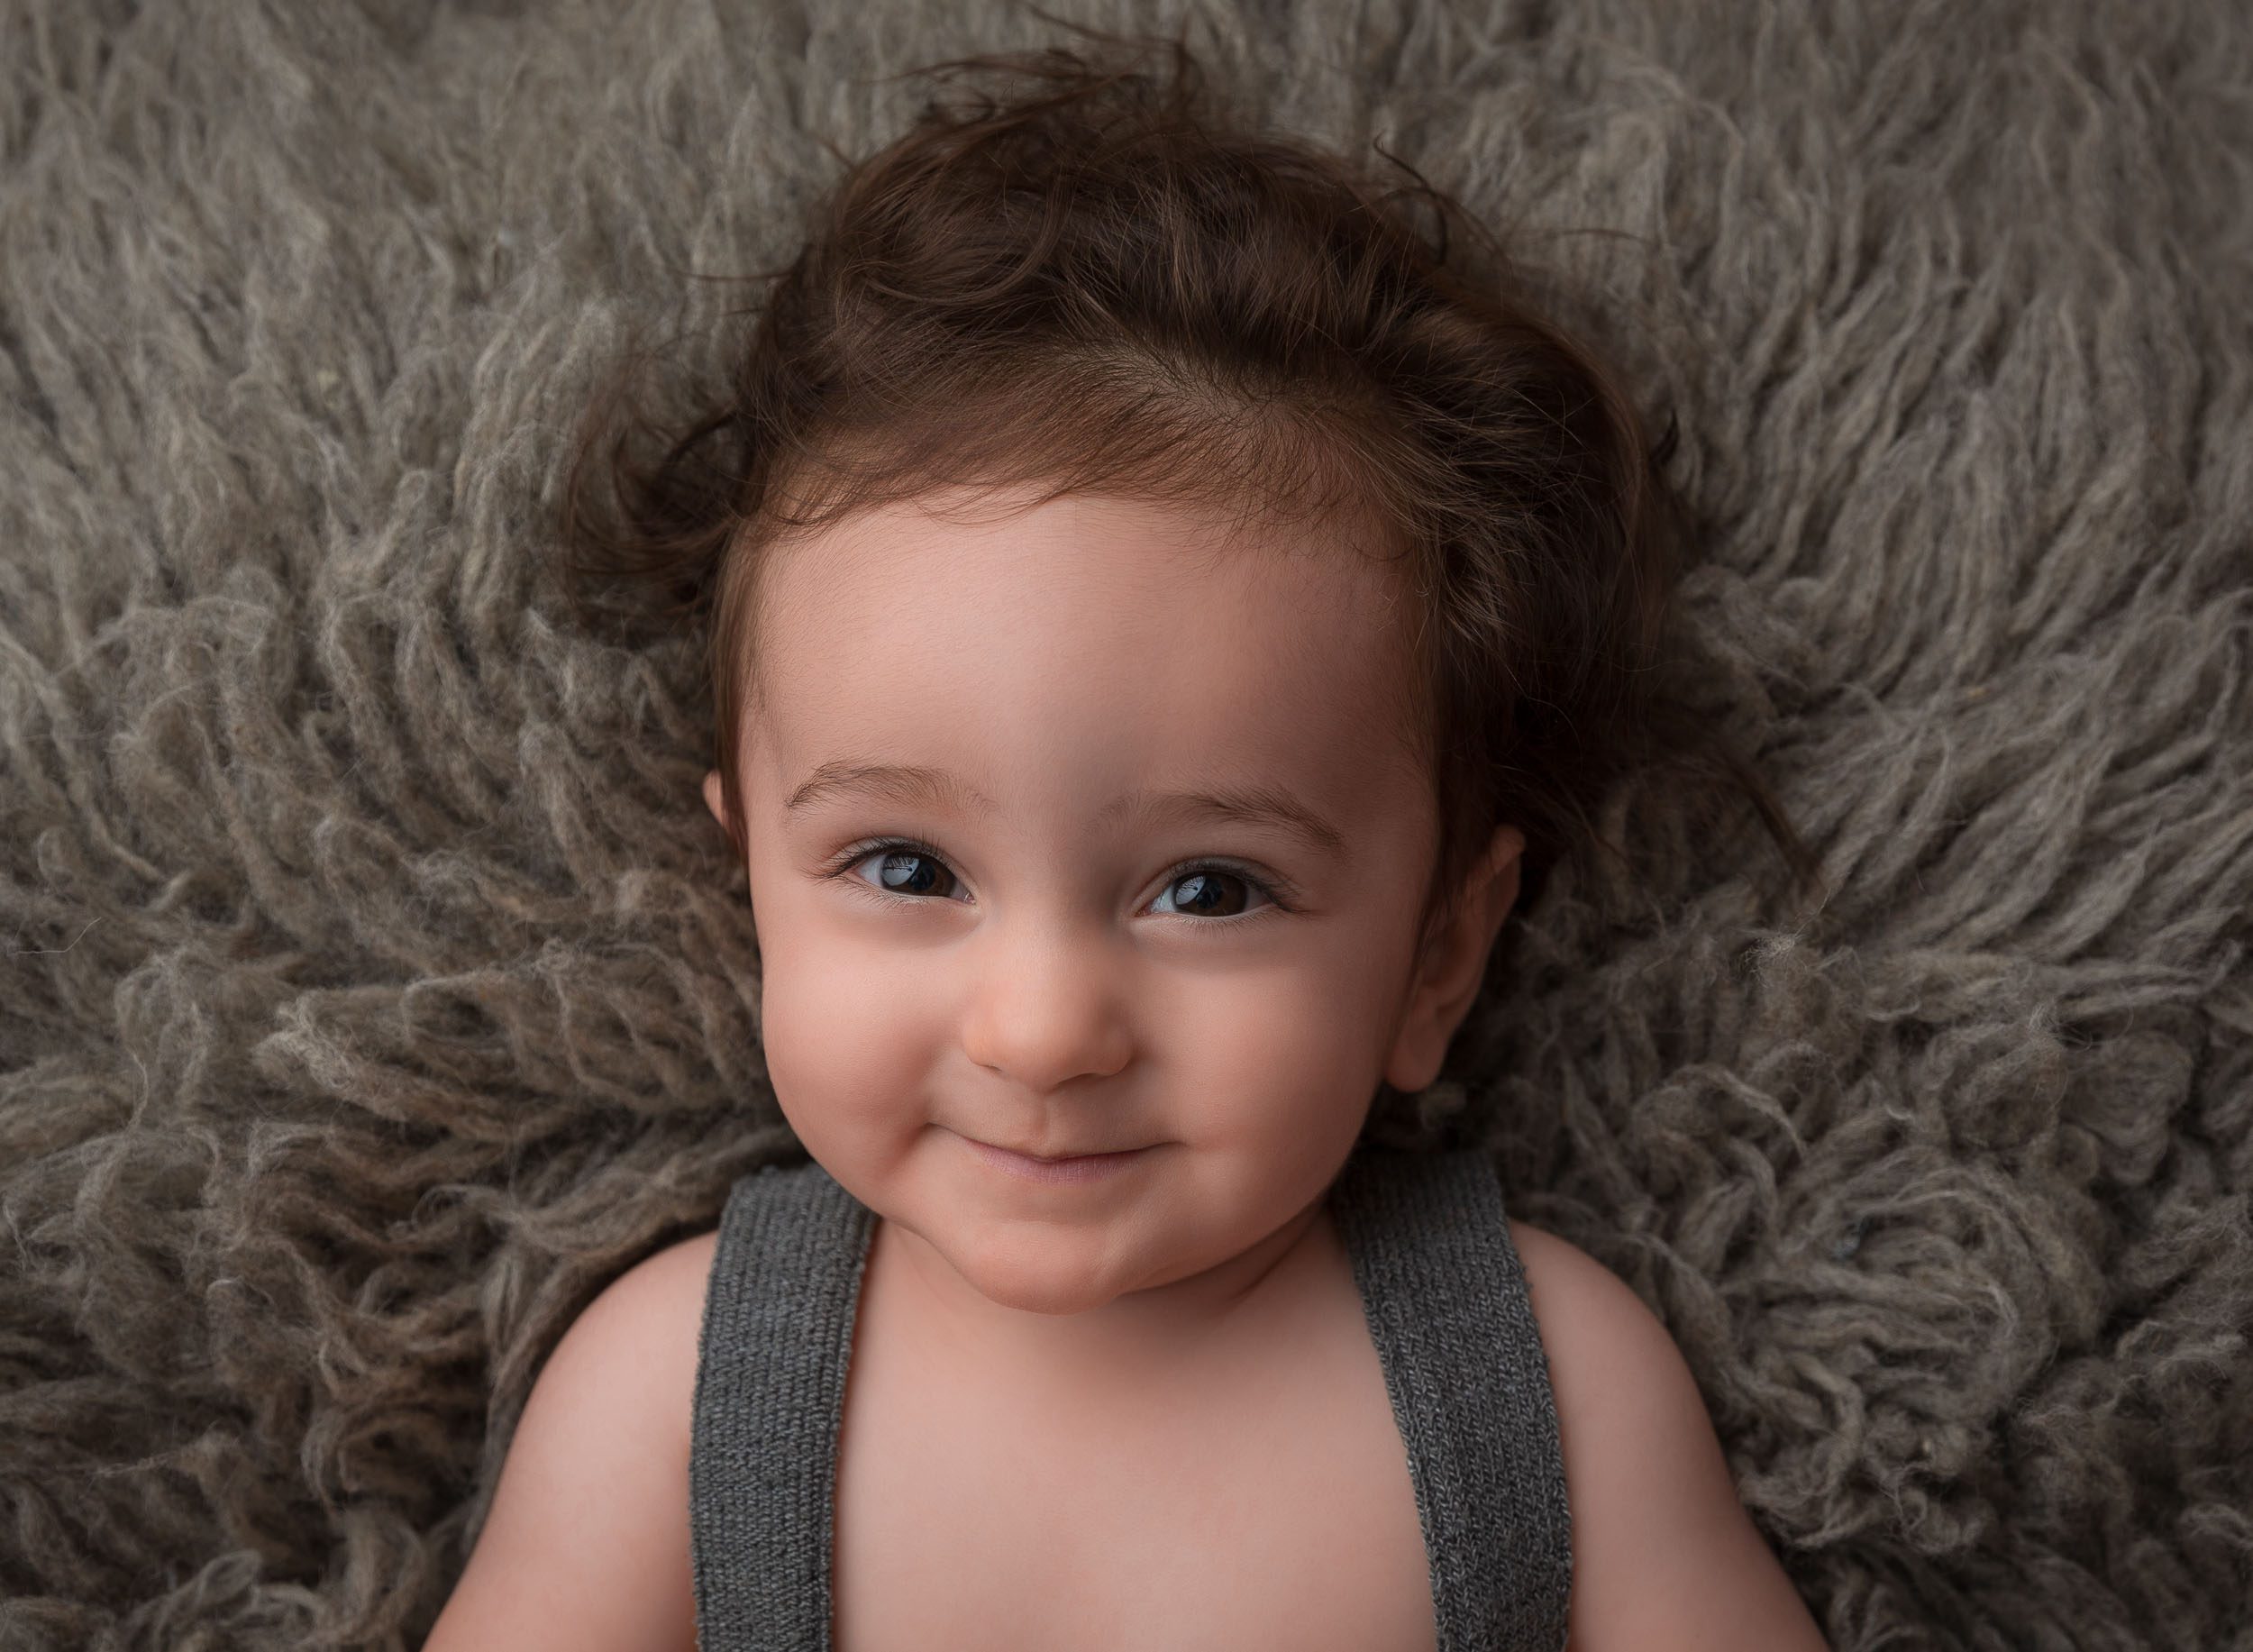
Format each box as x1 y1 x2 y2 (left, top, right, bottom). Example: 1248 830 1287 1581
1510 1221 1825 1652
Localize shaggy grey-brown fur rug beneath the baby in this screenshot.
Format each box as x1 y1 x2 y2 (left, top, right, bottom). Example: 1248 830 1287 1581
0 0 2253 1652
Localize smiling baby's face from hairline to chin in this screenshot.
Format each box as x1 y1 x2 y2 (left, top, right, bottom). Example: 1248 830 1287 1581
706 482 1499 1314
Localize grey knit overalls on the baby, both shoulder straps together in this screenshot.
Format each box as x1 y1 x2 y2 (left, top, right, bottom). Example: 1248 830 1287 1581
689 1143 1573 1652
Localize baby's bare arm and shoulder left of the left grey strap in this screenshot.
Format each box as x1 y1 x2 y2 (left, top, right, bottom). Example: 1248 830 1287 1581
424 1233 715 1652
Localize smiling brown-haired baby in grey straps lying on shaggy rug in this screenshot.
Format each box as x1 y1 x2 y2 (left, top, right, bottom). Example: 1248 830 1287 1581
428 25 1823 1652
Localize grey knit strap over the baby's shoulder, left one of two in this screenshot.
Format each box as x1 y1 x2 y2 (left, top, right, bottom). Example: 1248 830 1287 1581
689 1163 877 1652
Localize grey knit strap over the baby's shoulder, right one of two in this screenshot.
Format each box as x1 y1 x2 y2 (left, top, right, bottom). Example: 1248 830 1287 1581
1332 1145 1573 1652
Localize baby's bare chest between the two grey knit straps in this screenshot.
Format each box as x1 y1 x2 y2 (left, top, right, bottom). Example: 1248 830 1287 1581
832 1289 1437 1652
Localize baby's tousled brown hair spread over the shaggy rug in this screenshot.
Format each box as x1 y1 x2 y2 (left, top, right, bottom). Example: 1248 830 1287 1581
563 30 1819 964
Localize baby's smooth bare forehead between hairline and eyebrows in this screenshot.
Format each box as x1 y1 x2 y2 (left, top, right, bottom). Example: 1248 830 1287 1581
753 505 1410 784
